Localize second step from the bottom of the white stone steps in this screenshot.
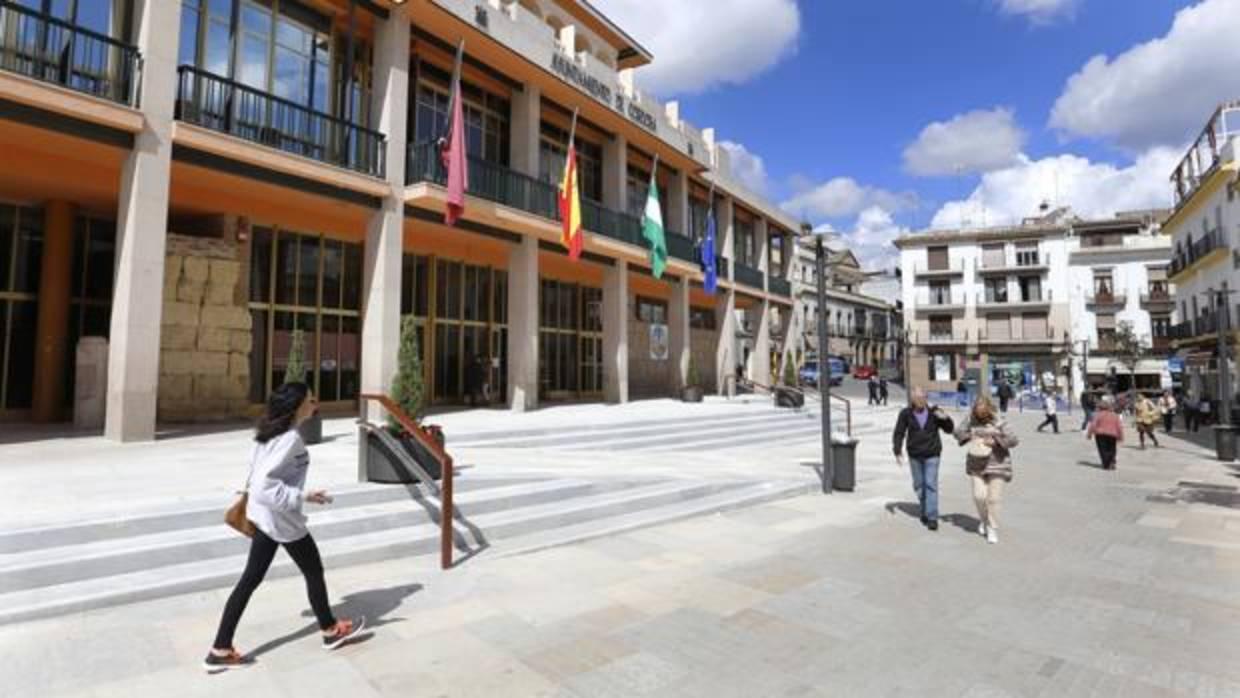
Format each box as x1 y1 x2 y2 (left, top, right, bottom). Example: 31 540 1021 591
0 479 605 594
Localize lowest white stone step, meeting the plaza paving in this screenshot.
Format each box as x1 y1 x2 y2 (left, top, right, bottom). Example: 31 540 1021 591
0 481 763 624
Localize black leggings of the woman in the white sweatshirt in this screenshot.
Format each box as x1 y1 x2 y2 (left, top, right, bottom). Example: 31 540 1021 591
215 531 336 650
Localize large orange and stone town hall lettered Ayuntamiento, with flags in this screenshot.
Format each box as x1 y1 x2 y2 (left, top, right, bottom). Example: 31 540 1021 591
0 0 797 440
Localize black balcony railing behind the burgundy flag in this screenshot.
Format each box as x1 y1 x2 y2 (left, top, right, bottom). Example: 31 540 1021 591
405 143 558 221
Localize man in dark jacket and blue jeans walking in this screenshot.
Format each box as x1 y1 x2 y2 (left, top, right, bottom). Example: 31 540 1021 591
892 388 956 531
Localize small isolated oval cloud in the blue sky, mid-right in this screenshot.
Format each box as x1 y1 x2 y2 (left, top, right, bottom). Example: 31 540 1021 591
904 108 1025 176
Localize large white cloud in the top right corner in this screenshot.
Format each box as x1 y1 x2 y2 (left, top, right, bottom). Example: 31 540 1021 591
1050 0 1240 152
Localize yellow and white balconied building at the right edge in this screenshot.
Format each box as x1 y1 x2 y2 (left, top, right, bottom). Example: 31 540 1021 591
1162 102 1240 398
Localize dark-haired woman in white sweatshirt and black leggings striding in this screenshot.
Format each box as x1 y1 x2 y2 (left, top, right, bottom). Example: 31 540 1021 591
202 383 366 673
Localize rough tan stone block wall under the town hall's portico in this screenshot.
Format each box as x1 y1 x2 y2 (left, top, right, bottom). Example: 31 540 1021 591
159 234 253 422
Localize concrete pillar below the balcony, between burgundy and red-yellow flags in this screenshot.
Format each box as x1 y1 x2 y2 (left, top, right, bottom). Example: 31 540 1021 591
508 236 538 412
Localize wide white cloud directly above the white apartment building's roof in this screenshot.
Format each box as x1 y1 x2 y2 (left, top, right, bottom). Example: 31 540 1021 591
930 148 1179 228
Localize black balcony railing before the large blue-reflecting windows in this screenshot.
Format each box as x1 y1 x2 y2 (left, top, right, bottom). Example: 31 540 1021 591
176 66 386 177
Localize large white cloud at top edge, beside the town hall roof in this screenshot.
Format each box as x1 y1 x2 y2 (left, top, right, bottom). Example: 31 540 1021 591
595 0 801 95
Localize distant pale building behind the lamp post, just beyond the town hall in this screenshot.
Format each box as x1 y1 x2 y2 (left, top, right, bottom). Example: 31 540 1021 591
787 236 900 374
